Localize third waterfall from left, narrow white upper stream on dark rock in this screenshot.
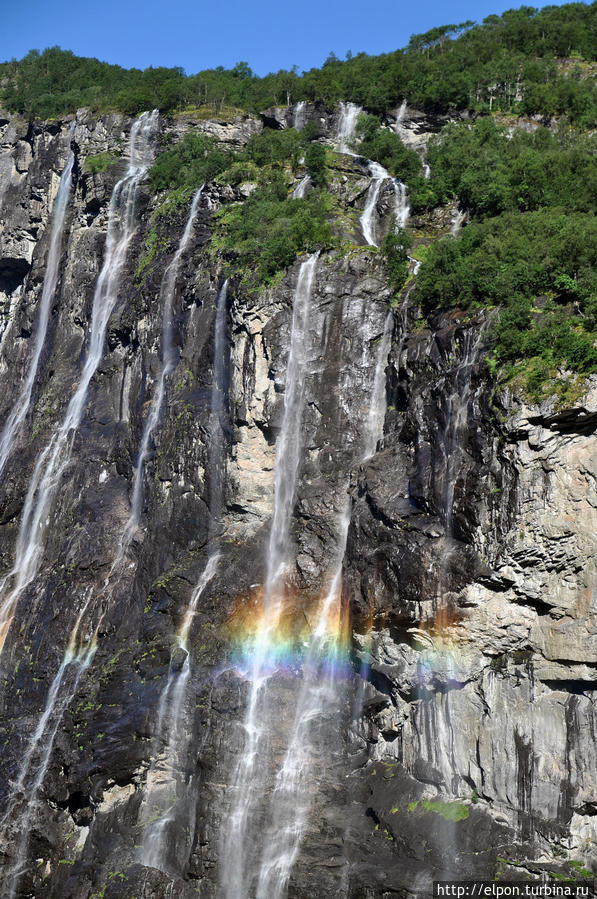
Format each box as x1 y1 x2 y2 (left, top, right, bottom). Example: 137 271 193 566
112 185 204 569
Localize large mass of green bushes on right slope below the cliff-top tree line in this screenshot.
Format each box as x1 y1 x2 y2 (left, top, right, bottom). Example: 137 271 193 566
410 101 597 400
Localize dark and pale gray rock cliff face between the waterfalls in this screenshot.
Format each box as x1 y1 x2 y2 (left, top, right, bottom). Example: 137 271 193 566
0 106 597 899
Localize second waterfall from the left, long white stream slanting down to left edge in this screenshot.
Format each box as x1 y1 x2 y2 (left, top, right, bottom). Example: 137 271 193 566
0 110 158 649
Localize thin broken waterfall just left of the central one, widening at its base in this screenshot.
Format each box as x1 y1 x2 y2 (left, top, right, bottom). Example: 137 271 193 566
139 280 228 873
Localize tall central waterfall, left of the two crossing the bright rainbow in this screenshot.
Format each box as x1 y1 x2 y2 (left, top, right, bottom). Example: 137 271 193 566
220 254 318 899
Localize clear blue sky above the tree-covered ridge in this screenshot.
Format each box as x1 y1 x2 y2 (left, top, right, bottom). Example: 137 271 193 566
0 0 576 75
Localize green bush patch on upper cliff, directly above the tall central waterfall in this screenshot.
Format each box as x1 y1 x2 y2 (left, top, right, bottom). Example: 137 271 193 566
148 121 334 286
